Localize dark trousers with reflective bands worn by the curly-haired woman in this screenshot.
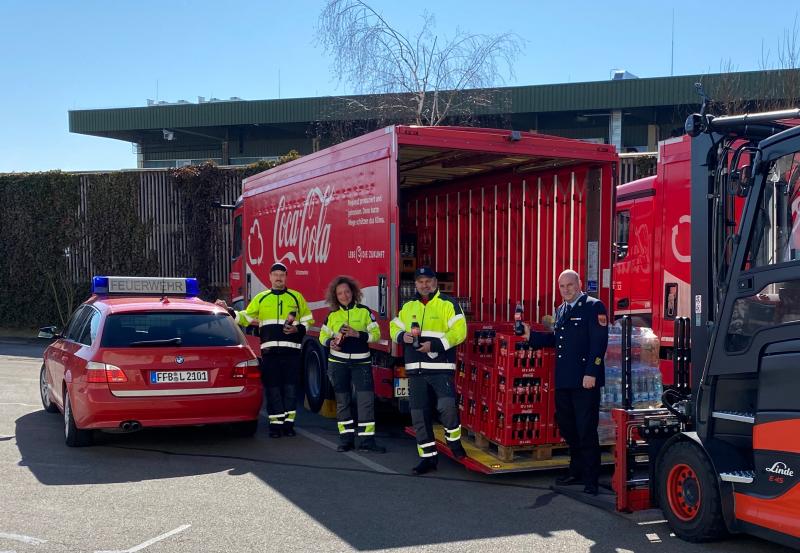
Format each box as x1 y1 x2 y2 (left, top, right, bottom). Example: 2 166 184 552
328 359 375 444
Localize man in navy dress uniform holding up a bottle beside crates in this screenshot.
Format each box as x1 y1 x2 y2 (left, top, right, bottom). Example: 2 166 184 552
525 270 608 495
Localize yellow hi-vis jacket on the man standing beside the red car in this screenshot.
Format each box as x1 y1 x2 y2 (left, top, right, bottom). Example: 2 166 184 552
236 288 314 353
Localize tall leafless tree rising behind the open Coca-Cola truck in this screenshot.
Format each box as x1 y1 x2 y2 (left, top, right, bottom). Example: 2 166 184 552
318 0 523 125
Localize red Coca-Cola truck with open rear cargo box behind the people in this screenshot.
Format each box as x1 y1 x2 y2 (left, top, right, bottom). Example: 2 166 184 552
230 126 618 411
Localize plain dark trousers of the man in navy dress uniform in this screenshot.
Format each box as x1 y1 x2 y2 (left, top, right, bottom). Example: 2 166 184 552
556 387 600 486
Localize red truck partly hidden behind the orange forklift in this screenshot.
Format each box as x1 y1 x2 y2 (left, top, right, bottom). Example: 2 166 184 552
613 135 751 385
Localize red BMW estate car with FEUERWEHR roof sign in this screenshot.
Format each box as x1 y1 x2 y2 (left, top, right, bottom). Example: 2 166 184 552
39 277 263 446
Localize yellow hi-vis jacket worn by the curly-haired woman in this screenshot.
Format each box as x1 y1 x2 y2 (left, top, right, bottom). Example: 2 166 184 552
319 303 381 363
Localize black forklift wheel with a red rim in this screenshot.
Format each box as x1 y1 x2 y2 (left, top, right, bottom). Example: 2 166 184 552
656 442 728 542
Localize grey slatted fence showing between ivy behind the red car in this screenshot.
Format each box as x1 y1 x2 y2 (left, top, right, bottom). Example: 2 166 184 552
68 168 242 287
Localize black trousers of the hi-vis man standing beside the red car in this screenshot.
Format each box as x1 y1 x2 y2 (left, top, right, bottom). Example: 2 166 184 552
261 350 300 430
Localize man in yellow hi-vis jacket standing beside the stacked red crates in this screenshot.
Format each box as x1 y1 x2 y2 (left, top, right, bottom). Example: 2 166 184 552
389 267 467 474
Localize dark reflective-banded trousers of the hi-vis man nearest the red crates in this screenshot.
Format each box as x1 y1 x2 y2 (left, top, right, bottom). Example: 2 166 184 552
408 371 461 457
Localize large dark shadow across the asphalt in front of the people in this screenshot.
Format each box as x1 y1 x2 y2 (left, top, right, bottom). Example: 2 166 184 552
16 411 792 553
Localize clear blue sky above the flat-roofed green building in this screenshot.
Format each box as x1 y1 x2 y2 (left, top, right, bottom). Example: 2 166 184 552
0 0 800 172
